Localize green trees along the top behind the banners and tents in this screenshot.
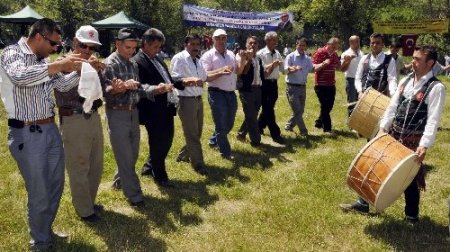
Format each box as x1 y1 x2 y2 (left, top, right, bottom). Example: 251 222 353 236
0 0 450 55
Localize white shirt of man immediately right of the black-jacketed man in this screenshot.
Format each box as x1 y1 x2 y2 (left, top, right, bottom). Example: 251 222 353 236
170 50 208 96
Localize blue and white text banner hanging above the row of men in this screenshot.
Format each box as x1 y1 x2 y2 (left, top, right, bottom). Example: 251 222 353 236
183 4 294 31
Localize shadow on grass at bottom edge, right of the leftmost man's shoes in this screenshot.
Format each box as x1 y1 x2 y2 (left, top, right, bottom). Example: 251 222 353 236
86 211 167 251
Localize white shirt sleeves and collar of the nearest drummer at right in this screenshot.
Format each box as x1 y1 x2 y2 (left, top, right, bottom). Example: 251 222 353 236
380 71 446 148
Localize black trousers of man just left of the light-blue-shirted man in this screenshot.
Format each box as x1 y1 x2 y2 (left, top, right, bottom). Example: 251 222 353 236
258 80 281 139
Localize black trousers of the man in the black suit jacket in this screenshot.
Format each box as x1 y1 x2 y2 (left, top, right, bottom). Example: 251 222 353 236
144 115 174 181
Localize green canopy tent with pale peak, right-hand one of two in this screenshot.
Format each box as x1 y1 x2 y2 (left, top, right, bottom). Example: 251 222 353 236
92 11 149 57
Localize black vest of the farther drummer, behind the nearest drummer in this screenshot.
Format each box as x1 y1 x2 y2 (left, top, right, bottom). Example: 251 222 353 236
361 54 392 96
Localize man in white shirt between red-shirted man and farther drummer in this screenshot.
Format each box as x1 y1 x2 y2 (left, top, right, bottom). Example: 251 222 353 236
341 35 363 116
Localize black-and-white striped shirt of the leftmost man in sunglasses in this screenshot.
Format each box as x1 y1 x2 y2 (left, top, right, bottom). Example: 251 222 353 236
0 38 80 122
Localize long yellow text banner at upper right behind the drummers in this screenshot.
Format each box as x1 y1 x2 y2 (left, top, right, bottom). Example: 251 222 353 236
373 20 448 34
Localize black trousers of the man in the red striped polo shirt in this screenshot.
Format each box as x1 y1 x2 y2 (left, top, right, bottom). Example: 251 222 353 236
314 86 336 132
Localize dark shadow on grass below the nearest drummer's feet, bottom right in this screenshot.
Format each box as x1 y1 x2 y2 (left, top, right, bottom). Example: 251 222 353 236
364 216 450 251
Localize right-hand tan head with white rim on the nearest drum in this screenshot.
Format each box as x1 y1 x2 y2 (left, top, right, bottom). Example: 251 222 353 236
374 154 420 211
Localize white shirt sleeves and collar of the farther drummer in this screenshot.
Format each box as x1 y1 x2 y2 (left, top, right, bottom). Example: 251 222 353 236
355 52 397 96
